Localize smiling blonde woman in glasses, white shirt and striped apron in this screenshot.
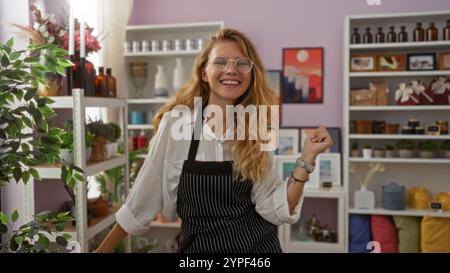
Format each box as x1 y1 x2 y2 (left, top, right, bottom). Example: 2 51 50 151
96 28 332 253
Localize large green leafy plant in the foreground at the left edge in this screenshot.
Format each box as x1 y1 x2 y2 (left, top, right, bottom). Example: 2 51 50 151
0 39 83 252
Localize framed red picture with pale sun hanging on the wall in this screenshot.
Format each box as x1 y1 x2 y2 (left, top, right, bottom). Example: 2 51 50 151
281 47 324 103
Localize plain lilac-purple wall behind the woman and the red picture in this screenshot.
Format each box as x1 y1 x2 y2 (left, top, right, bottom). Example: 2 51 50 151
130 0 450 127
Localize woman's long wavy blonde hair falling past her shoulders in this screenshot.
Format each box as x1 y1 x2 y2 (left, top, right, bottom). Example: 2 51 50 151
153 28 275 181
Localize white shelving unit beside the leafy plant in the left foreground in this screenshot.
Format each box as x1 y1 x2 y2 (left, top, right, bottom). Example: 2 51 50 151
24 89 130 252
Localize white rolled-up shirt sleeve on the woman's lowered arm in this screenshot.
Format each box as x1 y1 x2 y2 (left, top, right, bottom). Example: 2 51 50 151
116 113 170 235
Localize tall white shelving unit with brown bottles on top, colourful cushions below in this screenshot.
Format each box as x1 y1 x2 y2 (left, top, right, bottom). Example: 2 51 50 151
343 11 450 250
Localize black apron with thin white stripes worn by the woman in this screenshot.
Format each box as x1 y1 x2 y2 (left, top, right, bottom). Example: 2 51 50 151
177 116 282 253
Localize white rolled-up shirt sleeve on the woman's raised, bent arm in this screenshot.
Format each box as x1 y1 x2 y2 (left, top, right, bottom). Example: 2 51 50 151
252 155 303 225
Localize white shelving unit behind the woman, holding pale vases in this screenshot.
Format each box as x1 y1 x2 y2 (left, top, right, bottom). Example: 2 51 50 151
124 22 224 252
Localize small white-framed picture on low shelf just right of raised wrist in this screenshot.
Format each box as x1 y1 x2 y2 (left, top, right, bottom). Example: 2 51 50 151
316 153 341 187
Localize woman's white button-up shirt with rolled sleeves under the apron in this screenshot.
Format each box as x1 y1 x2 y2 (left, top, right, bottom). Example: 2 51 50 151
116 110 303 235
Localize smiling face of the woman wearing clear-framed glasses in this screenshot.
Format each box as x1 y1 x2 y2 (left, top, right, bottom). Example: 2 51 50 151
202 41 252 105
